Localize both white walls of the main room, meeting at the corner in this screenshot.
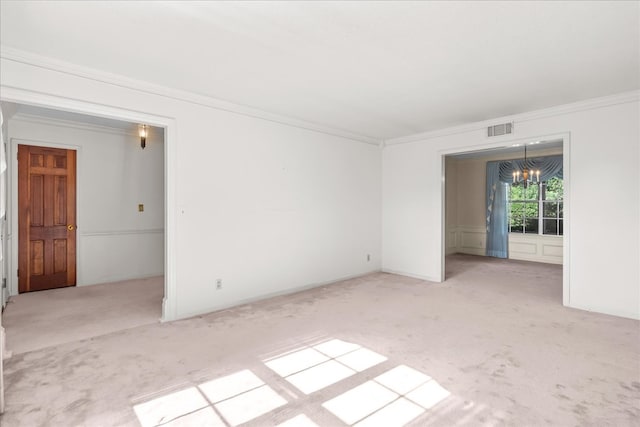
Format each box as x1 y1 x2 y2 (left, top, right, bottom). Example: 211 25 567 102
0 54 640 320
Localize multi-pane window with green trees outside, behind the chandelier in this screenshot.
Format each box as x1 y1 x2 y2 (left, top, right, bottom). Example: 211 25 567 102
509 178 563 236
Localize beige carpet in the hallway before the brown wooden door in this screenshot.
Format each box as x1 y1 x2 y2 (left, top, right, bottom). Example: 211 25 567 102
2 277 164 354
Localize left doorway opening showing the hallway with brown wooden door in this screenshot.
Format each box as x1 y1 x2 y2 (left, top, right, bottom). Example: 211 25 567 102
2 102 167 351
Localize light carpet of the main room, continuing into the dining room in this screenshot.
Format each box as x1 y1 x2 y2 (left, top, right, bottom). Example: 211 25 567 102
1 255 640 427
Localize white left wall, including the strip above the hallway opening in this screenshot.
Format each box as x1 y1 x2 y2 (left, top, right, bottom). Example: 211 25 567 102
0 56 381 320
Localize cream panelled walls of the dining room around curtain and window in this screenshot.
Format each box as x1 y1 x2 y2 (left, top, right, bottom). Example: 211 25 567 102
445 148 563 264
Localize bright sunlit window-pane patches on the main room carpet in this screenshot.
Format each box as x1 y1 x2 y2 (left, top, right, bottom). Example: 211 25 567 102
133 339 453 427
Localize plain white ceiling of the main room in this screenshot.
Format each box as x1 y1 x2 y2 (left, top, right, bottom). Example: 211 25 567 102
0 1 640 139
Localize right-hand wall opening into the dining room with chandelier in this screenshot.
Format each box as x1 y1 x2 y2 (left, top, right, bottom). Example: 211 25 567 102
443 138 568 301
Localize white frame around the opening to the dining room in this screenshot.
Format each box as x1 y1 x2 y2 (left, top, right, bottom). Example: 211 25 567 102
438 132 571 306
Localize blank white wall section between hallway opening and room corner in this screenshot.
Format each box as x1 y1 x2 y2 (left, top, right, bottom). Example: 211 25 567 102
170 108 381 320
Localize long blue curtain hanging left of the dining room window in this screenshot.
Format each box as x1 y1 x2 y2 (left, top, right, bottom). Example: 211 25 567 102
486 162 509 258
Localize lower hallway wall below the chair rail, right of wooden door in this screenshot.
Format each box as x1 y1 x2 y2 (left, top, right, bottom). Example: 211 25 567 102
78 229 164 286
